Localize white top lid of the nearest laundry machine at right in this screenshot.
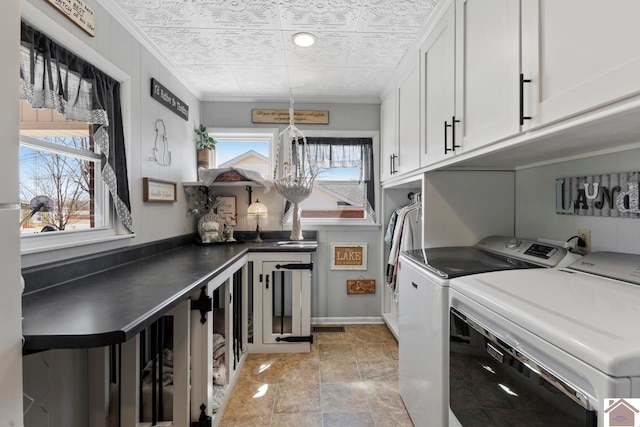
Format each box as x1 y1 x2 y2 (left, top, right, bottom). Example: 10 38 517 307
450 269 640 377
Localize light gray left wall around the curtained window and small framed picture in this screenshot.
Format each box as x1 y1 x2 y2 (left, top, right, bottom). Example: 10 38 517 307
22 0 200 267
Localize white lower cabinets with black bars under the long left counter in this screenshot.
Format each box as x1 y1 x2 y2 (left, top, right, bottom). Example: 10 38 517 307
106 258 246 427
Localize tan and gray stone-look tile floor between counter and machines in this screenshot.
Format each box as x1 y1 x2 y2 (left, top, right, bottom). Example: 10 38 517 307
218 325 413 427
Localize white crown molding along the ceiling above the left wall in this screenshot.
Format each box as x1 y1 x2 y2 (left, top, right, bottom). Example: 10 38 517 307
96 0 203 100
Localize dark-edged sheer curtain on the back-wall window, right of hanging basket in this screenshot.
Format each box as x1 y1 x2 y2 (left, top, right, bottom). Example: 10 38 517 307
285 137 376 223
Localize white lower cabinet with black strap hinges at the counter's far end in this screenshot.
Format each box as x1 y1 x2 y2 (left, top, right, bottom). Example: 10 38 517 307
247 252 313 352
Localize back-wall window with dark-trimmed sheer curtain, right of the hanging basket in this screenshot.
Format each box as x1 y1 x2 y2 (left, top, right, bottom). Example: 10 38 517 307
285 137 376 223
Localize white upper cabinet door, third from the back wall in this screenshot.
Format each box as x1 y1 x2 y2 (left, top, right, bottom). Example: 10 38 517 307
420 4 457 166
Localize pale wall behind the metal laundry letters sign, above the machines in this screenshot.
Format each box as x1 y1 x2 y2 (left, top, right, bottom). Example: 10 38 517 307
516 150 640 254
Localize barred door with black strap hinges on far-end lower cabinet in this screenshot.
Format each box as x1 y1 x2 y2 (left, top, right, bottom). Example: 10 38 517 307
262 261 311 344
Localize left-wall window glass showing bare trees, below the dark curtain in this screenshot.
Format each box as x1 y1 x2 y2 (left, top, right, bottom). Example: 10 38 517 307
20 100 109 235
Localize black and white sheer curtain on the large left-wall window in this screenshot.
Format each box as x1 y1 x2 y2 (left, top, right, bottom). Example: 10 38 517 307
20 22 133 233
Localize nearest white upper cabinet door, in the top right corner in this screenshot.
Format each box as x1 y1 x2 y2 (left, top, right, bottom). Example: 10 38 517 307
522 0 640 128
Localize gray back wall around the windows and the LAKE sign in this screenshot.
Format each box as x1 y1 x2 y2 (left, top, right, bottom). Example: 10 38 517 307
202 100 384 321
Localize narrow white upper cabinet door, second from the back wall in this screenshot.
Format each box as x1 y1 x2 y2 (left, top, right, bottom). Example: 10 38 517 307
397 52 420 174
